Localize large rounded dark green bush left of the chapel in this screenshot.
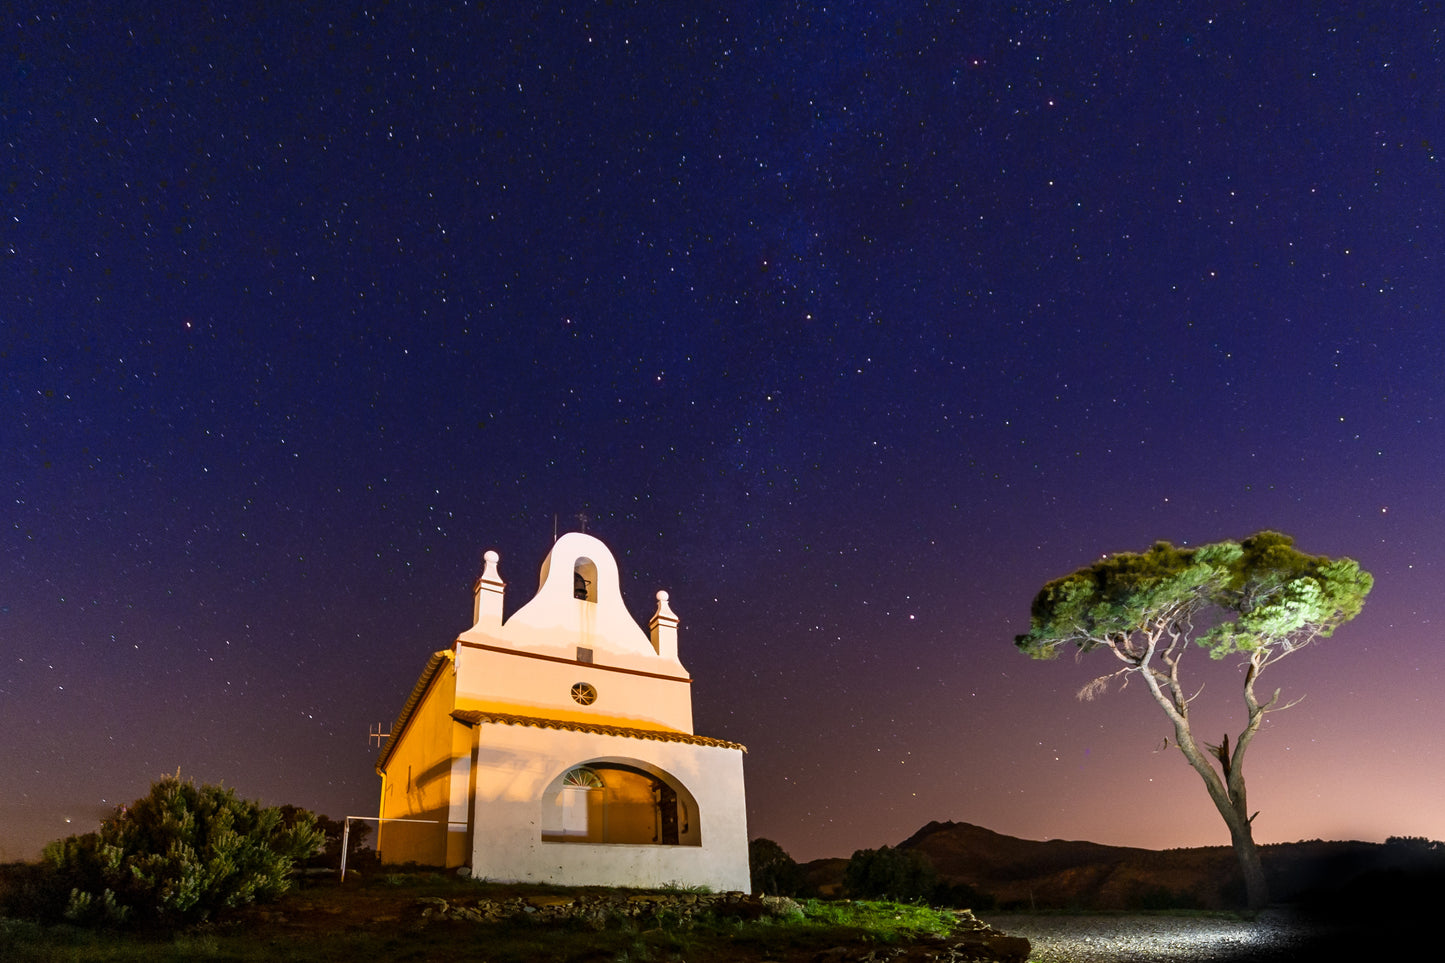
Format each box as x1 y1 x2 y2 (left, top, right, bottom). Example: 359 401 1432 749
42 776 322 925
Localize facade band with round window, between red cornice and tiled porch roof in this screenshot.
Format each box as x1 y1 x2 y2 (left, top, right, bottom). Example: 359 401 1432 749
457 642 692 733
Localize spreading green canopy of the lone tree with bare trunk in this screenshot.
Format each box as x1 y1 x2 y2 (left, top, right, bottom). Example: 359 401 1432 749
1014 532 1374 659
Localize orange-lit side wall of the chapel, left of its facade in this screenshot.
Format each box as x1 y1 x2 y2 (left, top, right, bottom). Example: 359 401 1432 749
377 664 456 866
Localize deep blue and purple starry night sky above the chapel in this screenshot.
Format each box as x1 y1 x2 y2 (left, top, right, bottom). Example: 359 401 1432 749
0 0 1445 859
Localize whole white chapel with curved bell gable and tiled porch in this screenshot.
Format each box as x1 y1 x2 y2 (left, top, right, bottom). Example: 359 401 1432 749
376 532 749 891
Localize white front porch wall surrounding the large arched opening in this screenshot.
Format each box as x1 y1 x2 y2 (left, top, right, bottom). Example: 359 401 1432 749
473 724 750 892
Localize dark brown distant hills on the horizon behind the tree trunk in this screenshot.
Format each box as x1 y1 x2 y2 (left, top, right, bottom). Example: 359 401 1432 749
805 823 1445 910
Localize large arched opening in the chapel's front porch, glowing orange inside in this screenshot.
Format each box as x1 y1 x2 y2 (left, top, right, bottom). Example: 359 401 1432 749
542 759 702 846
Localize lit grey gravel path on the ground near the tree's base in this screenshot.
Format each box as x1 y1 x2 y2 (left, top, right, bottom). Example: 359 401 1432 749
977 910 1324 963
